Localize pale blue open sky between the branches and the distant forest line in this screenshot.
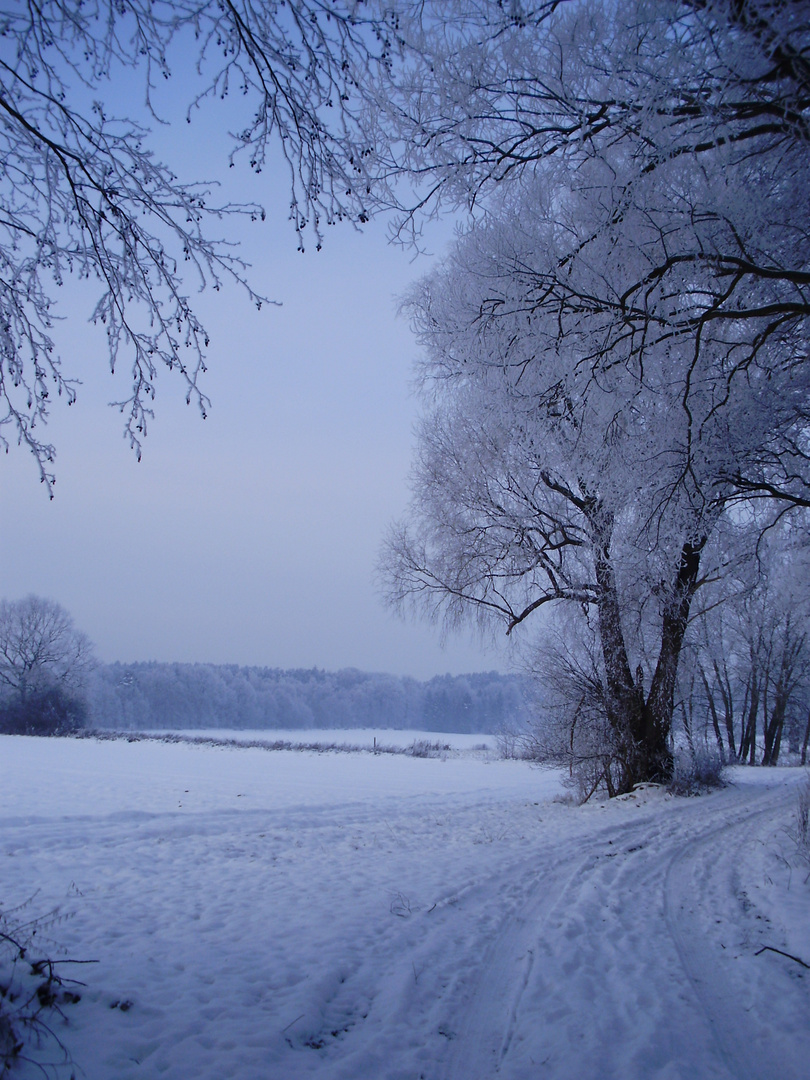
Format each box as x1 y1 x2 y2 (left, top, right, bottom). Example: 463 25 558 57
0 56 505 677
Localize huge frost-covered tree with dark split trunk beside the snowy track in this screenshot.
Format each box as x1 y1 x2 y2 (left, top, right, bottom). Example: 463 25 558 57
375 0 810 786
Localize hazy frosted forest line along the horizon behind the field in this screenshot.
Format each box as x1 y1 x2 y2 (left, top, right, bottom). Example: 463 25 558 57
89 662 530 732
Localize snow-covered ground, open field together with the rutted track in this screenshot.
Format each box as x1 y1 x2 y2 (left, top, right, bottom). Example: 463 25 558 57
0 733 810 1080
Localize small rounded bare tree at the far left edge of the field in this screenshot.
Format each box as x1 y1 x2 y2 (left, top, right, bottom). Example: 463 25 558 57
0 595 95 733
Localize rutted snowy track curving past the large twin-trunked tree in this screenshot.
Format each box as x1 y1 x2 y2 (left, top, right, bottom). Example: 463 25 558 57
444 789 807 1080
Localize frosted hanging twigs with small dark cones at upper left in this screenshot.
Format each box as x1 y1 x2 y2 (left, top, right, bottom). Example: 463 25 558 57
0 0 403 490
